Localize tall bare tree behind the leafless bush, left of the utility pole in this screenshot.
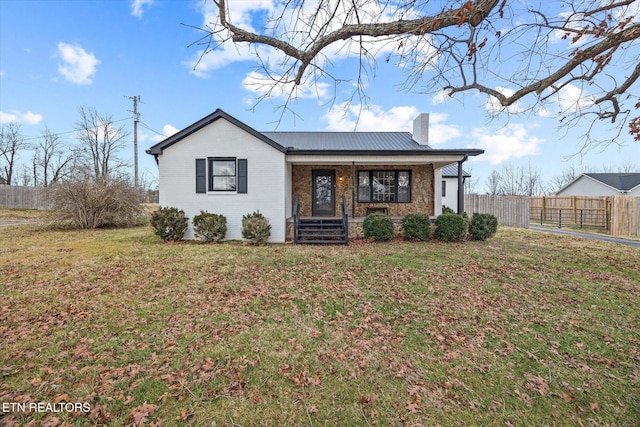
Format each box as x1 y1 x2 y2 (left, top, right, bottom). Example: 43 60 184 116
76 106 129 183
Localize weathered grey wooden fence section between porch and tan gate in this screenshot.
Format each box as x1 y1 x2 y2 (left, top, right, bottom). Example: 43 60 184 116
464 194 529 228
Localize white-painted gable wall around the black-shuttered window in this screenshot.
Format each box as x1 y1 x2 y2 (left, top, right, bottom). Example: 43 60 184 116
159 119 286 242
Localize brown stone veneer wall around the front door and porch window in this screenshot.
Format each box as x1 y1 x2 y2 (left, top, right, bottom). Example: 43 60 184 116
291 164 434 217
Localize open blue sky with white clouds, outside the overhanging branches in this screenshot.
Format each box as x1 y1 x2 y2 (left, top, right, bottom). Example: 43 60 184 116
0 0 640 192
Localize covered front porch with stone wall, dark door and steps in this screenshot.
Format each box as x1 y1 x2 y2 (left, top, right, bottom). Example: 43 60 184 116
287 153 466 243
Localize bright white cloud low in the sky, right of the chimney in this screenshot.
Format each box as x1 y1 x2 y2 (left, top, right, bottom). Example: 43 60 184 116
468 123 544 165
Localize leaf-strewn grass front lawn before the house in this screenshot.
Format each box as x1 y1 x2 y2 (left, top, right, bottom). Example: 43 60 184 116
0 226 640 426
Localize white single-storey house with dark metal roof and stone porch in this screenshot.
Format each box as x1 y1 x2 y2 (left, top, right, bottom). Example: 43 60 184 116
147 109 484 243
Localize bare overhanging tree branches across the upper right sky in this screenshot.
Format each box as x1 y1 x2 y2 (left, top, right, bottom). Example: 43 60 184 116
204 0 640 147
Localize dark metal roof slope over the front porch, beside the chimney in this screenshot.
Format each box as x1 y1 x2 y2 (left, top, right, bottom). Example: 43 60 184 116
262 132 432 154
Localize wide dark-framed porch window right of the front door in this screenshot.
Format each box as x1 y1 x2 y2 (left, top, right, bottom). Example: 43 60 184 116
358 170 411 203
